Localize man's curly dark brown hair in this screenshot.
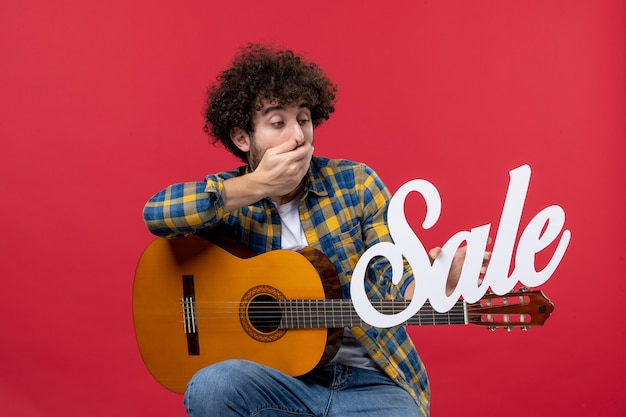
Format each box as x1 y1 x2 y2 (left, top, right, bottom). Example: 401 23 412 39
204 44 337 163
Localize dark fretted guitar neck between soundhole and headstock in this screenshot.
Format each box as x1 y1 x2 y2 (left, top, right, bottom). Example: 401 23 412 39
278 299 468 329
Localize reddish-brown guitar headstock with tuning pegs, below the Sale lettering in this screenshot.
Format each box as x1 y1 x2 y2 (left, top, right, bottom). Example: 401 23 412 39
467 288 554 331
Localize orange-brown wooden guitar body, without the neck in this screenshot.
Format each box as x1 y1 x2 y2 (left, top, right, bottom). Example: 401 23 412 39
133 236 342 393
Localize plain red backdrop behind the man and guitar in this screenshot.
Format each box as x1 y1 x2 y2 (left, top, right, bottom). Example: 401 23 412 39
0 0 626 417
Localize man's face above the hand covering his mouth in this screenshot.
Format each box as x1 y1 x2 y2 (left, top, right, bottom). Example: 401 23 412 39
248 101 313 170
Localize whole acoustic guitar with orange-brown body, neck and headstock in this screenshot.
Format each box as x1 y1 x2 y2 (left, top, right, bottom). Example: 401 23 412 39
133 236 554 393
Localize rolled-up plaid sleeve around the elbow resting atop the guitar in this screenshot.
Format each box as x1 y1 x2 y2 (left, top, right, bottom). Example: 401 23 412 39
143 175 224 238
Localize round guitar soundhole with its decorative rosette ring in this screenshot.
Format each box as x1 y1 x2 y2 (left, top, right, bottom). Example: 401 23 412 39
239 285 287 342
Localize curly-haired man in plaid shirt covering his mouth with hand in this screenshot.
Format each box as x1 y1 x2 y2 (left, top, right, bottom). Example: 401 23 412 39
144 45 464 417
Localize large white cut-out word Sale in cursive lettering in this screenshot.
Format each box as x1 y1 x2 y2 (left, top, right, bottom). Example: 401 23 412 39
350 165 571 327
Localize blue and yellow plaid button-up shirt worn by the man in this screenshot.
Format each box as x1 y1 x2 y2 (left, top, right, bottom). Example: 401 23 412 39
144 157 430 415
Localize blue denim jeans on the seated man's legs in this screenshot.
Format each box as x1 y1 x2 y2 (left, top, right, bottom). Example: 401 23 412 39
184 360 425 417
